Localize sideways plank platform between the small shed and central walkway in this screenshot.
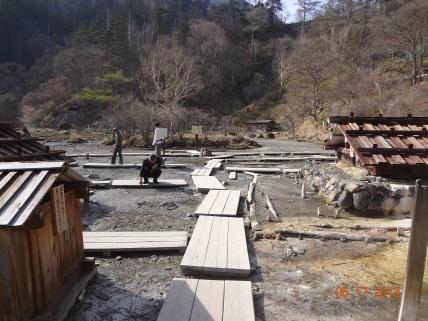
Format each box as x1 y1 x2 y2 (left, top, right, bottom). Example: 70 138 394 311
83 231 188 252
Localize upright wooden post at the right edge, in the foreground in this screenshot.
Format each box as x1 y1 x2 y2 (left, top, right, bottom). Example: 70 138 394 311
398 180 428 321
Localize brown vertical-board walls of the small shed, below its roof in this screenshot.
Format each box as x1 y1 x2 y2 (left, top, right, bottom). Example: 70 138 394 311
0 190 84 321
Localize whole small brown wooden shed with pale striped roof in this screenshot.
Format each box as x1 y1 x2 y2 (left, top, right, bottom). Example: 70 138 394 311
0 161 95 321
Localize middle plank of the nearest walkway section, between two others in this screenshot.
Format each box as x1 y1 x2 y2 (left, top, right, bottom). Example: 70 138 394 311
190 280 224 321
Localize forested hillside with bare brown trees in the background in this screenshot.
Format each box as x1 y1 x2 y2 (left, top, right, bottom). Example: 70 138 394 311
0 0 428 133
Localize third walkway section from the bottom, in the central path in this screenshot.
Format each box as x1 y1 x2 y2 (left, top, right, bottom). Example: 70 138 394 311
195 190 241 216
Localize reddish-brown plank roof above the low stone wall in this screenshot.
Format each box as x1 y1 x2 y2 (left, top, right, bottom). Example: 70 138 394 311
325 114 428 178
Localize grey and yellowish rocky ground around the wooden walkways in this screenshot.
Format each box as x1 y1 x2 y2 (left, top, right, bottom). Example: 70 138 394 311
47 141 428 321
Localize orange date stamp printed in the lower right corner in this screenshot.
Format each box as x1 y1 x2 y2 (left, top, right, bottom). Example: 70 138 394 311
335 286 401 301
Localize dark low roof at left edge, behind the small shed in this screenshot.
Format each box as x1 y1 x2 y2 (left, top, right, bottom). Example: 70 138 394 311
0 122 66 161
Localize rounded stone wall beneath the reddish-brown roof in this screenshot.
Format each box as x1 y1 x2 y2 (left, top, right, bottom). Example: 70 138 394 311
304 164 415 216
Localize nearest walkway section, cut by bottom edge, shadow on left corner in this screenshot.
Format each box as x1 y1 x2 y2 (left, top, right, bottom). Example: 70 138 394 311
157 279 255 321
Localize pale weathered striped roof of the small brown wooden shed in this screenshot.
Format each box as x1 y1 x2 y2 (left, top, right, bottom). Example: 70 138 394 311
0 162 89 227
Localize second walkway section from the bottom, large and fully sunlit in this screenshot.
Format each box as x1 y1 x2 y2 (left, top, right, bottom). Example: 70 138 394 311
181 216 251 277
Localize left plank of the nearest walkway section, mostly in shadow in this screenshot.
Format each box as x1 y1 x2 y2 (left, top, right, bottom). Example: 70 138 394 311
157 279 199 321
